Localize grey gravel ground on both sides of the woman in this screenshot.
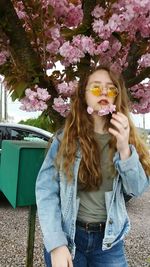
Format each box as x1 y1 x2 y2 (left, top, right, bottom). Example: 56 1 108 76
0 190 150 267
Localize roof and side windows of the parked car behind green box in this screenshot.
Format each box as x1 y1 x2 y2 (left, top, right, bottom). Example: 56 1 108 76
0 122 53 148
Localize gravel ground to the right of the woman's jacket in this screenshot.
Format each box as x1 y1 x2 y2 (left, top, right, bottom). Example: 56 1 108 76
126 190 150 267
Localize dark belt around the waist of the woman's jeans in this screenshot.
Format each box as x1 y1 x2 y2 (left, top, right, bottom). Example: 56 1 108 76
76 220 105 232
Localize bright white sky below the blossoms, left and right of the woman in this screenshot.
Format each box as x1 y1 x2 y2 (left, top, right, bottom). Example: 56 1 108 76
8 98 150 129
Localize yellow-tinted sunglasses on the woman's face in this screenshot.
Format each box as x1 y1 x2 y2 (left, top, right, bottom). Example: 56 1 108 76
89 85 119 97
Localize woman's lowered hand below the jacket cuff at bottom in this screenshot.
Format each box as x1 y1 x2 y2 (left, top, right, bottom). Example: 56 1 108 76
51 246 73 267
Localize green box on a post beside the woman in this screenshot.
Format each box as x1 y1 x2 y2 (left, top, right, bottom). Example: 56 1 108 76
0 140 47 208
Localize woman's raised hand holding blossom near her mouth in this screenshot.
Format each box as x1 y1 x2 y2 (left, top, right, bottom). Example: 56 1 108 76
108 112 131 160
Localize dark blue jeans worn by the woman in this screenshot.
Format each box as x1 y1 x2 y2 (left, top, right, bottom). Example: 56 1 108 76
44 226 128 267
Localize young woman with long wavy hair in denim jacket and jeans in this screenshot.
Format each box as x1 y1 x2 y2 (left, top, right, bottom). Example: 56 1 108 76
36 67 150 267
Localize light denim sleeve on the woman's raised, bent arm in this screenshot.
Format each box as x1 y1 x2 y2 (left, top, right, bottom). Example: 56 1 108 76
113 145 150 197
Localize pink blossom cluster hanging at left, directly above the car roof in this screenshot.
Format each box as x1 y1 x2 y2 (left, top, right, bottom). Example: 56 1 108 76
20 85 51 111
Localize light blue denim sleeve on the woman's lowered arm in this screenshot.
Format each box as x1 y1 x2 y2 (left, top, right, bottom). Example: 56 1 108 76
35 137 68 252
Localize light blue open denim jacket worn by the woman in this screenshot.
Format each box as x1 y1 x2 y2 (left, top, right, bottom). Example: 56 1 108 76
36 133 150 258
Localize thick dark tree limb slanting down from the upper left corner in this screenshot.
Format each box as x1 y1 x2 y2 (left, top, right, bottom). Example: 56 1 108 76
0 0 42 79
